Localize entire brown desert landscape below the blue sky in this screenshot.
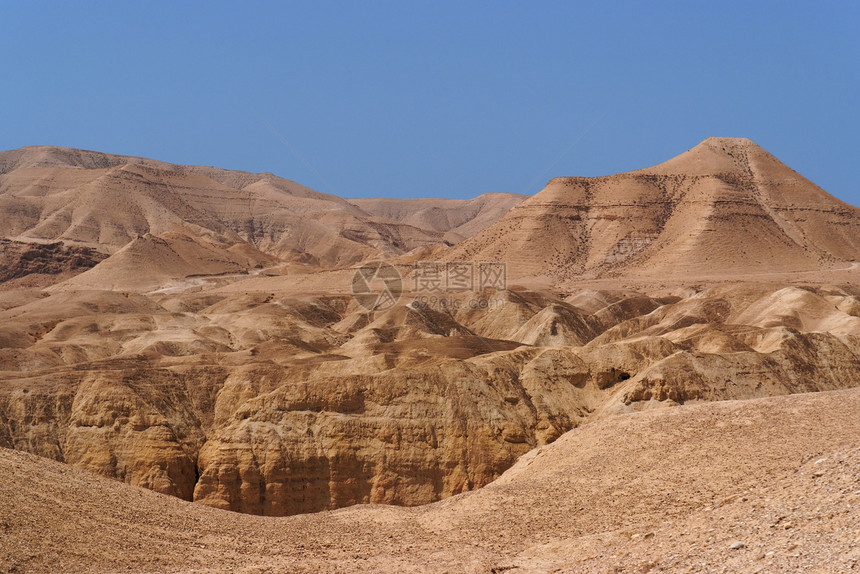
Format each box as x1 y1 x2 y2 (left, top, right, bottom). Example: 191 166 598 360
0 138 860 573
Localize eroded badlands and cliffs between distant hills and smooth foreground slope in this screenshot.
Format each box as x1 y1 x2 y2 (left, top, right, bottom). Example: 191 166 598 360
0 285 860 515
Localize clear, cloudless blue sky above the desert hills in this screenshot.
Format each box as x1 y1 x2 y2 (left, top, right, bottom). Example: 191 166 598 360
0 1 860 205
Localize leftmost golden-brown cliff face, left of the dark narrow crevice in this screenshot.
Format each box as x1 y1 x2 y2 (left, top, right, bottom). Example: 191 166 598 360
0 361 223 500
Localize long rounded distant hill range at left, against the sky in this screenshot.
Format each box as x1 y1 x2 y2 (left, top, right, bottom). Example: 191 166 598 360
0 146 524 272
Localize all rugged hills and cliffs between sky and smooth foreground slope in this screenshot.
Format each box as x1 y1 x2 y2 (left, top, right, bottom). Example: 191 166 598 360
0 138 860 528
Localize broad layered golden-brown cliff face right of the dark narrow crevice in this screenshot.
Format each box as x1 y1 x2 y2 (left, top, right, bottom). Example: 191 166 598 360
195 350 586 515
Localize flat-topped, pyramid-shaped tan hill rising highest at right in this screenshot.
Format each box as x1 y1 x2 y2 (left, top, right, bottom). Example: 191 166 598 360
445 138 860 281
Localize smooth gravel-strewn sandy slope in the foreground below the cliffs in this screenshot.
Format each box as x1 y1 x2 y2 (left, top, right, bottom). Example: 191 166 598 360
0 389 860 573
